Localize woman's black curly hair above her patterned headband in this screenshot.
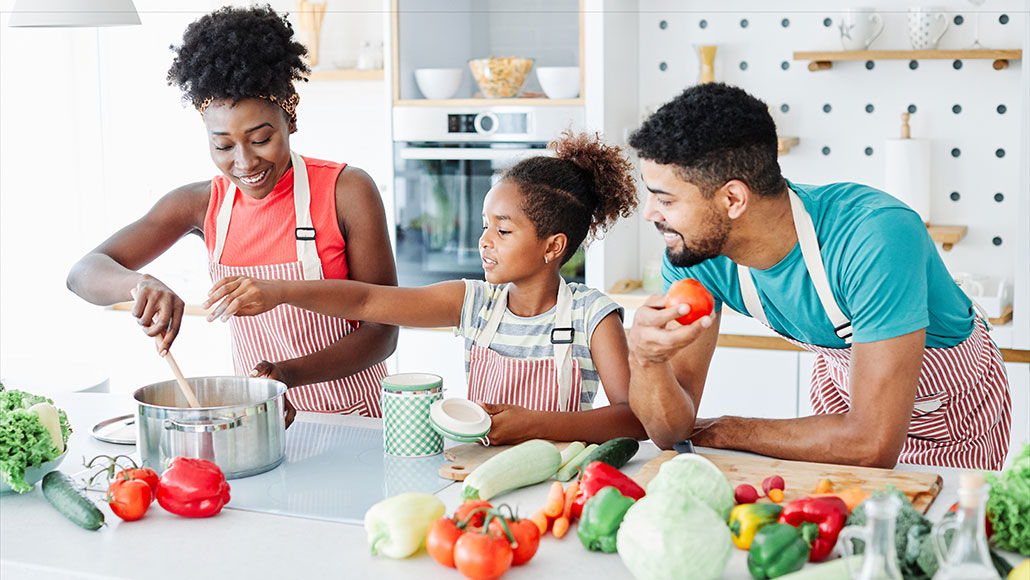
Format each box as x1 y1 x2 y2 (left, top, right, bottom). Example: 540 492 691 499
168 5 310 112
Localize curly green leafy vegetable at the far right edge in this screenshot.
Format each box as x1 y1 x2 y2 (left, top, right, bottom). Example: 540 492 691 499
987 444 1030 556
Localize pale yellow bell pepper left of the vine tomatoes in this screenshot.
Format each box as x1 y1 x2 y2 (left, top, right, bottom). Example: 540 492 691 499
365 491 446 558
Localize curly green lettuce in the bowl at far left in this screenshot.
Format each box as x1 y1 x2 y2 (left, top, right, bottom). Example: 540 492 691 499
0 383 71 493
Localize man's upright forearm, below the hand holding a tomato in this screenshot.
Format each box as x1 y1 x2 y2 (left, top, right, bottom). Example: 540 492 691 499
629 360 697 449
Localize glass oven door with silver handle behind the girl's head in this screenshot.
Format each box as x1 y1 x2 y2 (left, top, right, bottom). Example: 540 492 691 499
393 143 582 286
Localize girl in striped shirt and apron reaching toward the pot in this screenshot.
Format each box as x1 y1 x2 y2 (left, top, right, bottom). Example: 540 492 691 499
205 132 645 443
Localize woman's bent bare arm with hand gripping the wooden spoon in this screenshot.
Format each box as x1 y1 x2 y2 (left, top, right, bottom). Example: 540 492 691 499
67 181 211 349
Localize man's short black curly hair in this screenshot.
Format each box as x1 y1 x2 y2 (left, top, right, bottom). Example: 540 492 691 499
629 82 786 197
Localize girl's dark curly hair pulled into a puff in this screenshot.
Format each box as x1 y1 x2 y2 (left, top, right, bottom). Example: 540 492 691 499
503 131 637 264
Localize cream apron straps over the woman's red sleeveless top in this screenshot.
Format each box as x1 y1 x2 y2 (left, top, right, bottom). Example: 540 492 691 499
211 151 322 280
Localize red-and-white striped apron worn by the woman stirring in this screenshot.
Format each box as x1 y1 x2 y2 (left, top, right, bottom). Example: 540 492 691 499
208 152 386 417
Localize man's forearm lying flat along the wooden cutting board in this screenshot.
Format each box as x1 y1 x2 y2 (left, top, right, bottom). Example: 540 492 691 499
691 414 904 468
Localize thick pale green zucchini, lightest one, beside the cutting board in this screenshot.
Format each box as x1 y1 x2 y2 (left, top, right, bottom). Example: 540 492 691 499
461 439 561 500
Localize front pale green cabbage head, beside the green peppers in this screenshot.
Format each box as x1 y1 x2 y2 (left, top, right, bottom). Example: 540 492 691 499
616 490 733 580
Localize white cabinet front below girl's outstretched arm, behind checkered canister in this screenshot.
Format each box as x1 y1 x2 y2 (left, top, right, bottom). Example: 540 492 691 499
390 328 469 398
